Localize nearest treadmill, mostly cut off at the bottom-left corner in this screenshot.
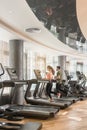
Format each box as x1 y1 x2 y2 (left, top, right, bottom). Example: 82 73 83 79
0 63 42 130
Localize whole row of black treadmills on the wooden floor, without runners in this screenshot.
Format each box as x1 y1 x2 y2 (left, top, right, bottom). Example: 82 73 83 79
0 63 86 130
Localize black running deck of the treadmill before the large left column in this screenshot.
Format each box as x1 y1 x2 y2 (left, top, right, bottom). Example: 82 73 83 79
6 105 59 118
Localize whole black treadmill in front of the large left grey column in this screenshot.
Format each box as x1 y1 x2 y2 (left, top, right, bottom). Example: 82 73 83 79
0 65 59 119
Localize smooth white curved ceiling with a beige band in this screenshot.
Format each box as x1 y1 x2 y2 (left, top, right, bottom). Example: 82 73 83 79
0 0 87 59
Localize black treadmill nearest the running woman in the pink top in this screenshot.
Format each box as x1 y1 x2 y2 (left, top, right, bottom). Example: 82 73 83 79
25 70 72 109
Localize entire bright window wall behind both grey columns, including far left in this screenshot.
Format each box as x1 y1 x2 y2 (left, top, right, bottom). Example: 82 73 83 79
0 41 87 79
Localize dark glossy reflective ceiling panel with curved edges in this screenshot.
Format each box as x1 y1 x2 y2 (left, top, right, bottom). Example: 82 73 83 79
26 0 85 43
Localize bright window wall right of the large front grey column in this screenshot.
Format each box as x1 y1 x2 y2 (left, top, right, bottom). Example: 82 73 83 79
24 45 87 80
